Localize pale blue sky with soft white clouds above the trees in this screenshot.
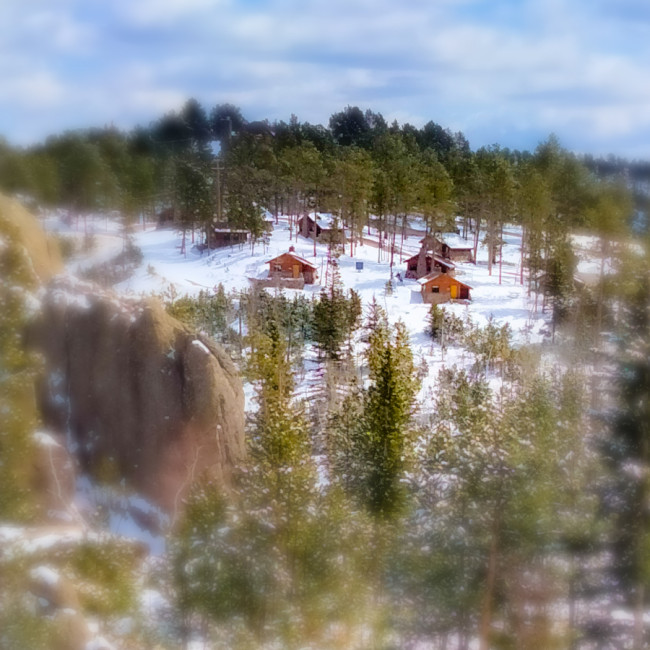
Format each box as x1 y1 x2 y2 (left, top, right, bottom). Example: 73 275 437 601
0 0 650 159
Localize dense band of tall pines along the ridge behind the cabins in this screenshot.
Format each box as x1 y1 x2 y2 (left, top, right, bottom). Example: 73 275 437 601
0 99 636 276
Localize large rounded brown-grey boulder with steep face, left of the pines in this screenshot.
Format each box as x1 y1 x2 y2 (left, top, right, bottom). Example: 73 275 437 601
30 278 244 515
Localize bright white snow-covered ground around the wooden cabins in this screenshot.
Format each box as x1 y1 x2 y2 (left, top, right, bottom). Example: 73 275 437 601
45 210 548 408
